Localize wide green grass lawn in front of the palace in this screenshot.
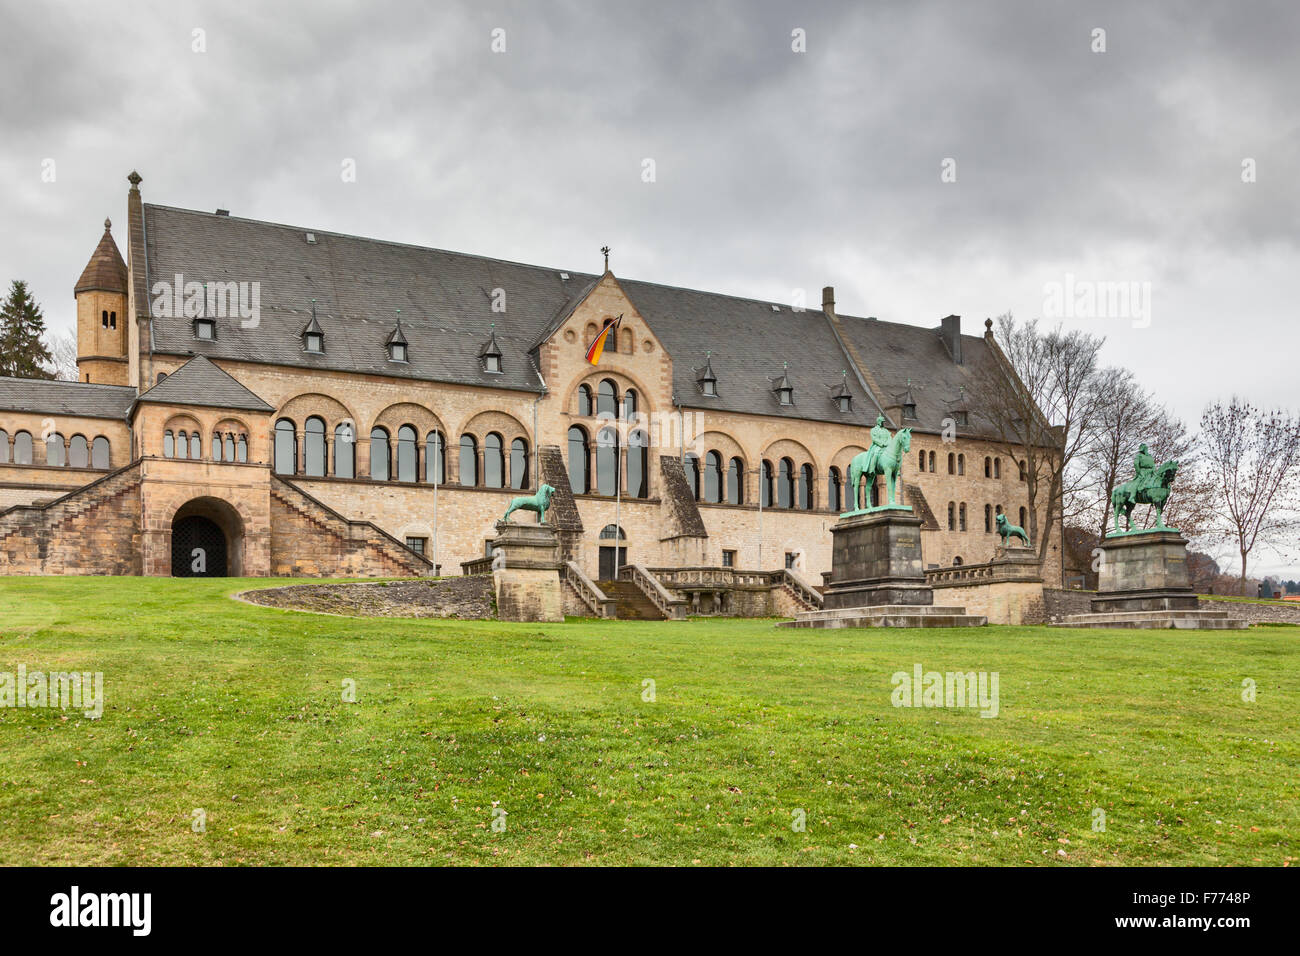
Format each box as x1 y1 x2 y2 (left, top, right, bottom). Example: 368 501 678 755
0 578 1300 865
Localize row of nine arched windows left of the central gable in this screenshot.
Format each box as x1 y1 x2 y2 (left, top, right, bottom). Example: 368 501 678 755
272 415 529 488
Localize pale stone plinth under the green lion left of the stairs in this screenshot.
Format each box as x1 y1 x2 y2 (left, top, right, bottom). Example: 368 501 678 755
491 522 564 622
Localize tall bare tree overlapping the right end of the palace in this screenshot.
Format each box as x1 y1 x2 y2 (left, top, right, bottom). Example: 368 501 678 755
976 313 1105 572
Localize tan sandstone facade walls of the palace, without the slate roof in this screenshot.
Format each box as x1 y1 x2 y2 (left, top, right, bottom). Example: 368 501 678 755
0 176 1061 583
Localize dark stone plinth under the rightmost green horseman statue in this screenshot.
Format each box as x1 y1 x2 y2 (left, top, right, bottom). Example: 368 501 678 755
1092 531 1196 614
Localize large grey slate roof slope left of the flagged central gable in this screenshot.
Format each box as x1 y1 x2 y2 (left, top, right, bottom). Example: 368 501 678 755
144 204 597 392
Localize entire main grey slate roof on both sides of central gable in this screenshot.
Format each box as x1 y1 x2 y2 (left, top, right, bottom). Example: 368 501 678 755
144 204 1008 431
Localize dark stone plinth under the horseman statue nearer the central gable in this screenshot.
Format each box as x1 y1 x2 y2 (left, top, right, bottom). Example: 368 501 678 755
823 510 935 610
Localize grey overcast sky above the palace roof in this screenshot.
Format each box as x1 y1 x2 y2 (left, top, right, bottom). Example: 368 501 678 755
0 0 1300 574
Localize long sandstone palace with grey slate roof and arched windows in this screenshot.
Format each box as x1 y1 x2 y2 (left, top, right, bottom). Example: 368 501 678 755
0 173 1061 606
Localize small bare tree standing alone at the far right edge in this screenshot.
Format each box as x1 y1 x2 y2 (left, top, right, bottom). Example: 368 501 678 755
1201 395 1300 596
